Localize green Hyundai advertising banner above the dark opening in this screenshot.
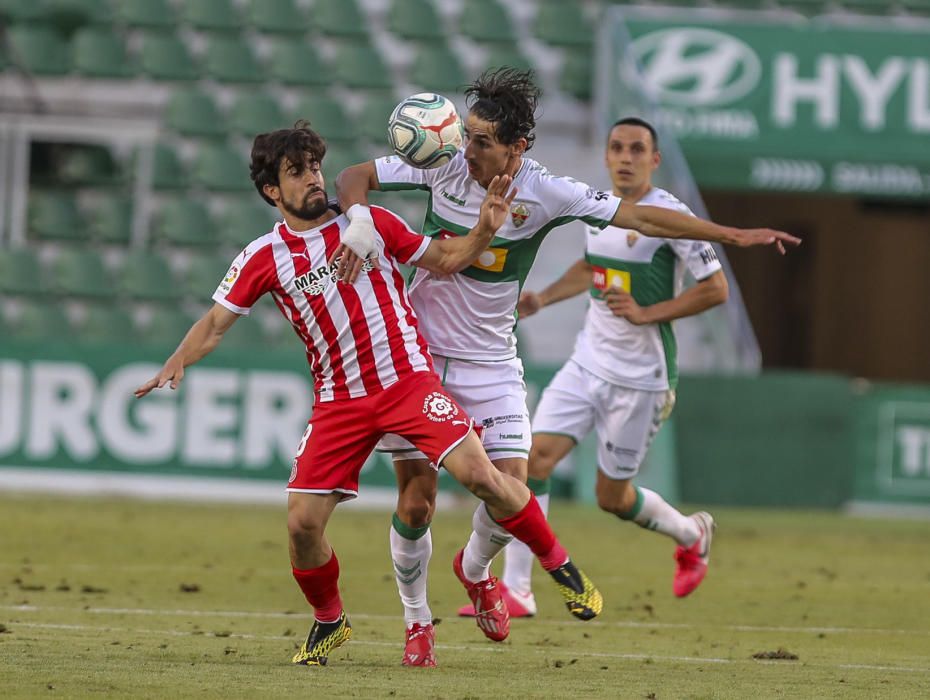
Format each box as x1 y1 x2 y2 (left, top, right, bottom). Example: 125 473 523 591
598 8 930 198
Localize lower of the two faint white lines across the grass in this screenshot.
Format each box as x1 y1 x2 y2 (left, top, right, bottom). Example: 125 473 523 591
11 615 930 674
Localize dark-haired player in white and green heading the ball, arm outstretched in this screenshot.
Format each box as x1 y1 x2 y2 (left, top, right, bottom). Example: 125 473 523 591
336 68 799 641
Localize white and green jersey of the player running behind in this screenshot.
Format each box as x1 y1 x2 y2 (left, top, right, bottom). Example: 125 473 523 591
572 187 721 391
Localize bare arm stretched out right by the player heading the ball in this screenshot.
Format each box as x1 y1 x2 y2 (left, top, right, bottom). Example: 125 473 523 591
611 201 801 255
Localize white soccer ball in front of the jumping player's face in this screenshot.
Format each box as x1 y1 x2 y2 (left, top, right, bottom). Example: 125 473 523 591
388 92 464 168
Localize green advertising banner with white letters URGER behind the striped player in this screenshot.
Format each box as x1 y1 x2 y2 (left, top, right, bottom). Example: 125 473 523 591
0 340 572 496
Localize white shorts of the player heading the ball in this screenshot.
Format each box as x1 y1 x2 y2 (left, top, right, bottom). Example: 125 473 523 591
376 355 532 462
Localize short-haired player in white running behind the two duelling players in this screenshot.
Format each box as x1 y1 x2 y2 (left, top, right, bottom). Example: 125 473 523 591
478 117 727 617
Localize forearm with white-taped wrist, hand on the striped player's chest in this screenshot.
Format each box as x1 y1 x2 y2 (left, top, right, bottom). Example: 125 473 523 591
328 160 381 283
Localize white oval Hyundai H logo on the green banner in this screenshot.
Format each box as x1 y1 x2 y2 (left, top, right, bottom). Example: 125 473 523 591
632 27 762 107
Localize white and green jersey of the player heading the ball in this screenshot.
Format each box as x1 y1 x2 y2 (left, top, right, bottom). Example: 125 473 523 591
375 151 620 361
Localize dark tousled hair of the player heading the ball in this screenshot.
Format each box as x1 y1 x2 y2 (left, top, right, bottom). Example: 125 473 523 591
465 66 539 150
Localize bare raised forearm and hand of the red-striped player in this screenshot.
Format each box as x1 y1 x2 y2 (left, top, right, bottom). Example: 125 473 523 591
413 175 517 275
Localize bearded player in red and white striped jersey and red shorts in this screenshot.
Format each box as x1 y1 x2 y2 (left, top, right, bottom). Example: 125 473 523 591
135 123 602 666
